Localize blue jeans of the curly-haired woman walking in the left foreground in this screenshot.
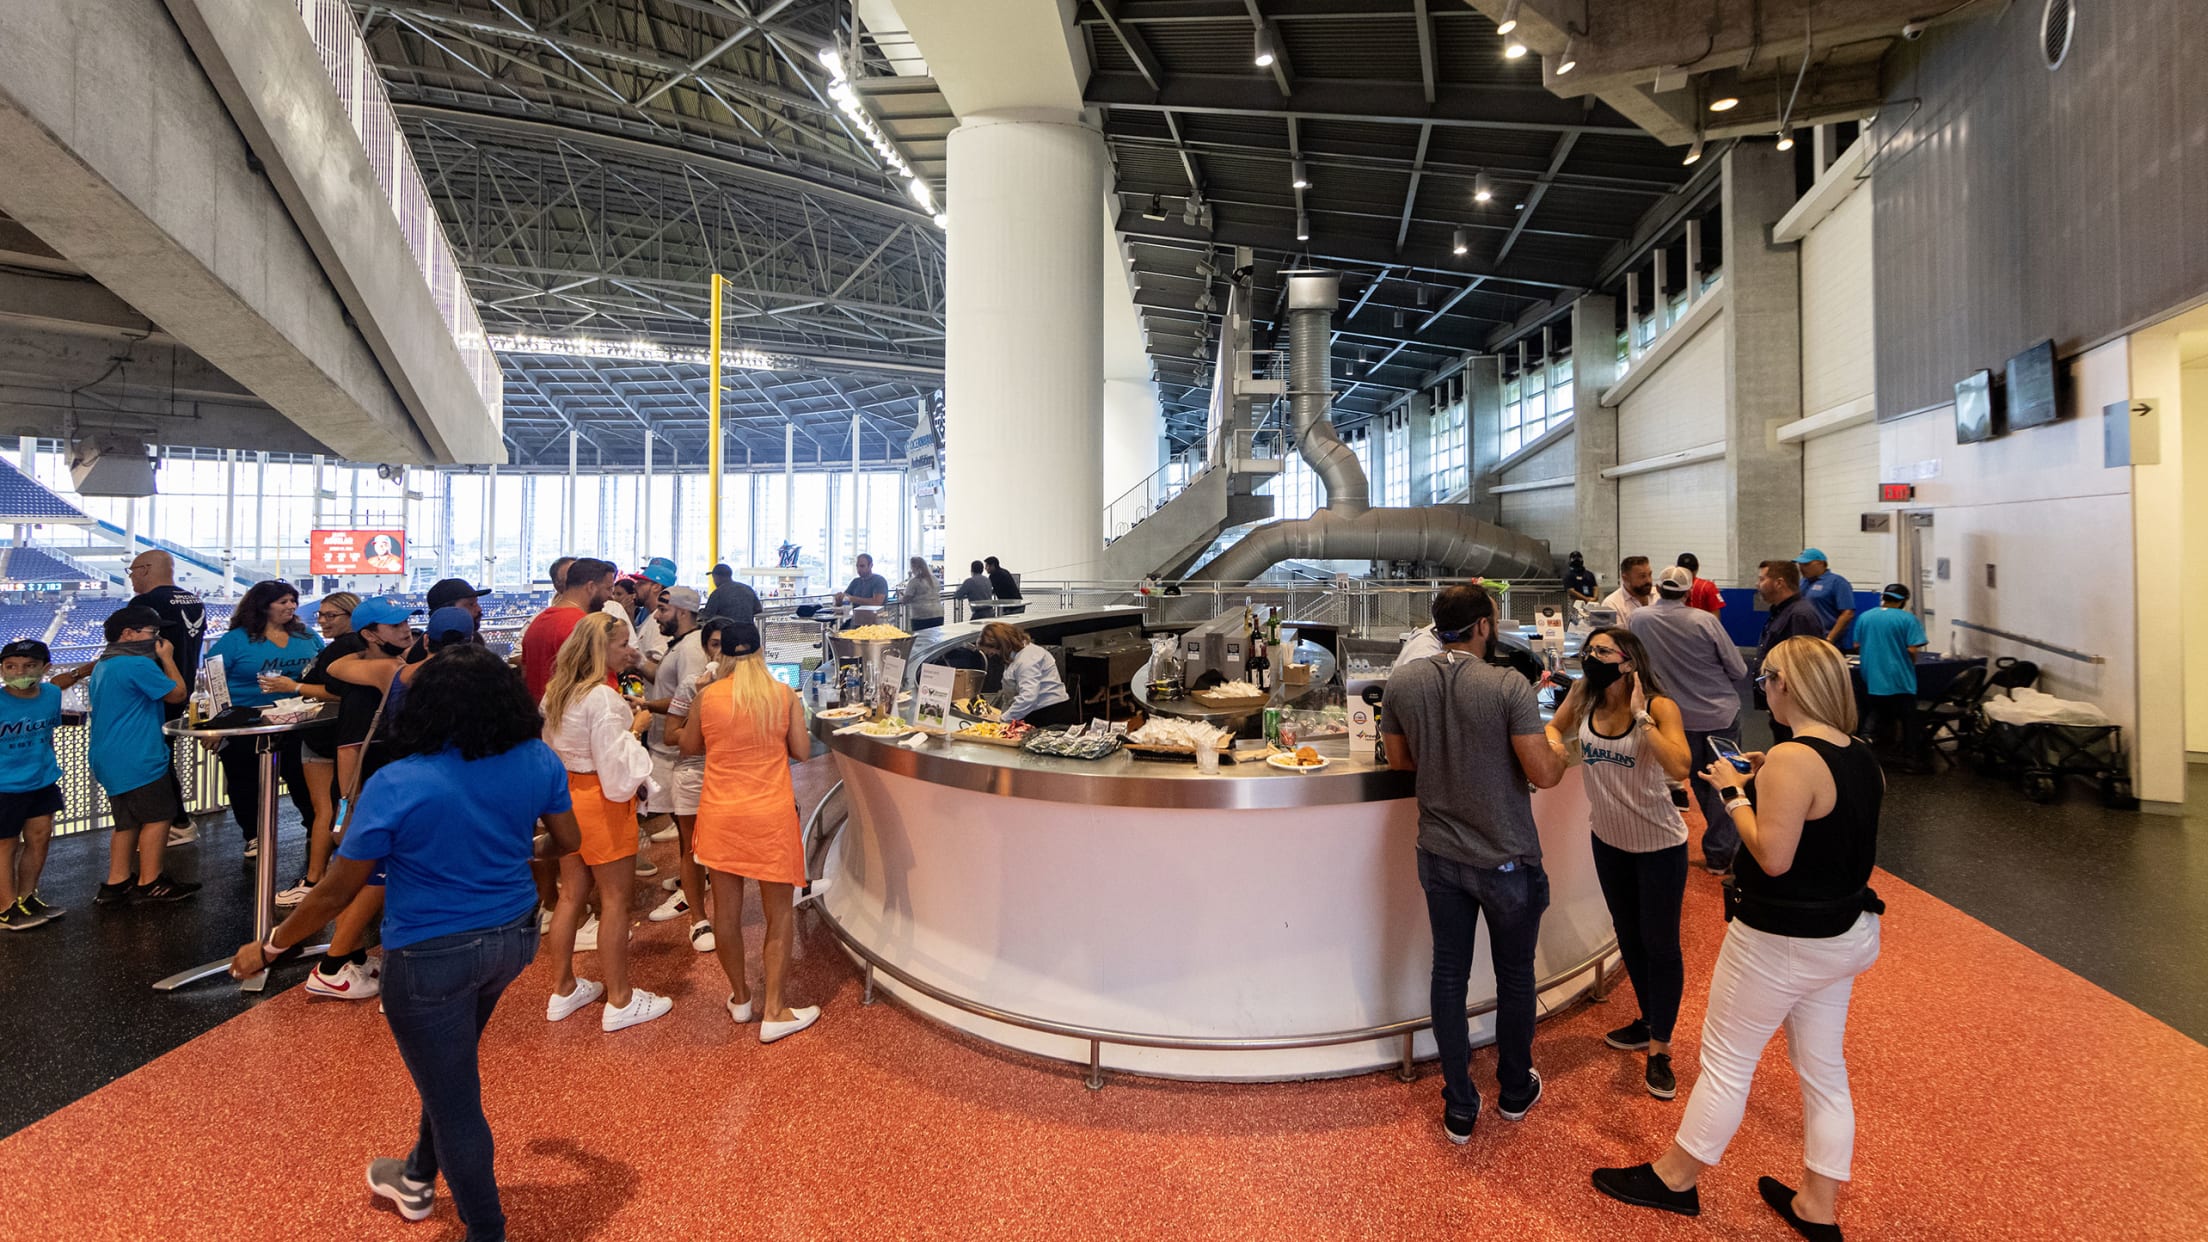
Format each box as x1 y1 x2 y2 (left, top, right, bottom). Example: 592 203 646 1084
384 902 537 1242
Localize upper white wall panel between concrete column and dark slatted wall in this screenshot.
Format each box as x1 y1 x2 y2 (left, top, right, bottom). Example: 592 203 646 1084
1802 186 1877 413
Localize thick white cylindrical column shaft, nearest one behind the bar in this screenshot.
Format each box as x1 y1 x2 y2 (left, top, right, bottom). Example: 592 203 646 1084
943 113 1106 579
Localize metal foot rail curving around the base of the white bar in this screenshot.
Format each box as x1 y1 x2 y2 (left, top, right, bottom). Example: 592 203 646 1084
806 780 1618 1092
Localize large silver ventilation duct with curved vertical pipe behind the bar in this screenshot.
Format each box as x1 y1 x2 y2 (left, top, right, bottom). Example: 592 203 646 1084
1188 272 1557 581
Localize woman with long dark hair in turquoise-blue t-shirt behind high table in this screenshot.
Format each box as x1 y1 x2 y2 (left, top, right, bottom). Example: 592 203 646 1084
208 579 322 857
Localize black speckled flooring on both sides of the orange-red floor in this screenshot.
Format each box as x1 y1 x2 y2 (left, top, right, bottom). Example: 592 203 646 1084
0 760 2208 1134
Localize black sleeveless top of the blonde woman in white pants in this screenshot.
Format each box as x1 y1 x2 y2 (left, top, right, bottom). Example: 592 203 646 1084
1724 738 1886 939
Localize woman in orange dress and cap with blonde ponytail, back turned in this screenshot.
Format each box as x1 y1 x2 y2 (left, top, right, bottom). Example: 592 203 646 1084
682 623 821 1043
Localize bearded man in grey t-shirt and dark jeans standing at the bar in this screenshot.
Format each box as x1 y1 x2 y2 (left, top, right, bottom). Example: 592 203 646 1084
1380 586 1563 1143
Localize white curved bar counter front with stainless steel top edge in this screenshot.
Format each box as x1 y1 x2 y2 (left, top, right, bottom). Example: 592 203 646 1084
819 729 1616 1085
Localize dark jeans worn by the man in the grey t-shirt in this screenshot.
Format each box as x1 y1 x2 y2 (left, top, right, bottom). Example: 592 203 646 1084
1418 851 1548 1116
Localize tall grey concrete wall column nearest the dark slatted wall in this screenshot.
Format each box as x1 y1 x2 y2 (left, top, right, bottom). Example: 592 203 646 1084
1722 144 1802 583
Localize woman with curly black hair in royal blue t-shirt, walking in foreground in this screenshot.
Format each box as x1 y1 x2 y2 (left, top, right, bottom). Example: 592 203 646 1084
230 645 581 1242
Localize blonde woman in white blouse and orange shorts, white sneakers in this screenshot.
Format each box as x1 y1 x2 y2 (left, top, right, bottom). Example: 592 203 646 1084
543 612 673 1032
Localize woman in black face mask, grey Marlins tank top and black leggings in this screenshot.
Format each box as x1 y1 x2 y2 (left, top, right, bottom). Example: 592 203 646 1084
1548 625 1694 1101
